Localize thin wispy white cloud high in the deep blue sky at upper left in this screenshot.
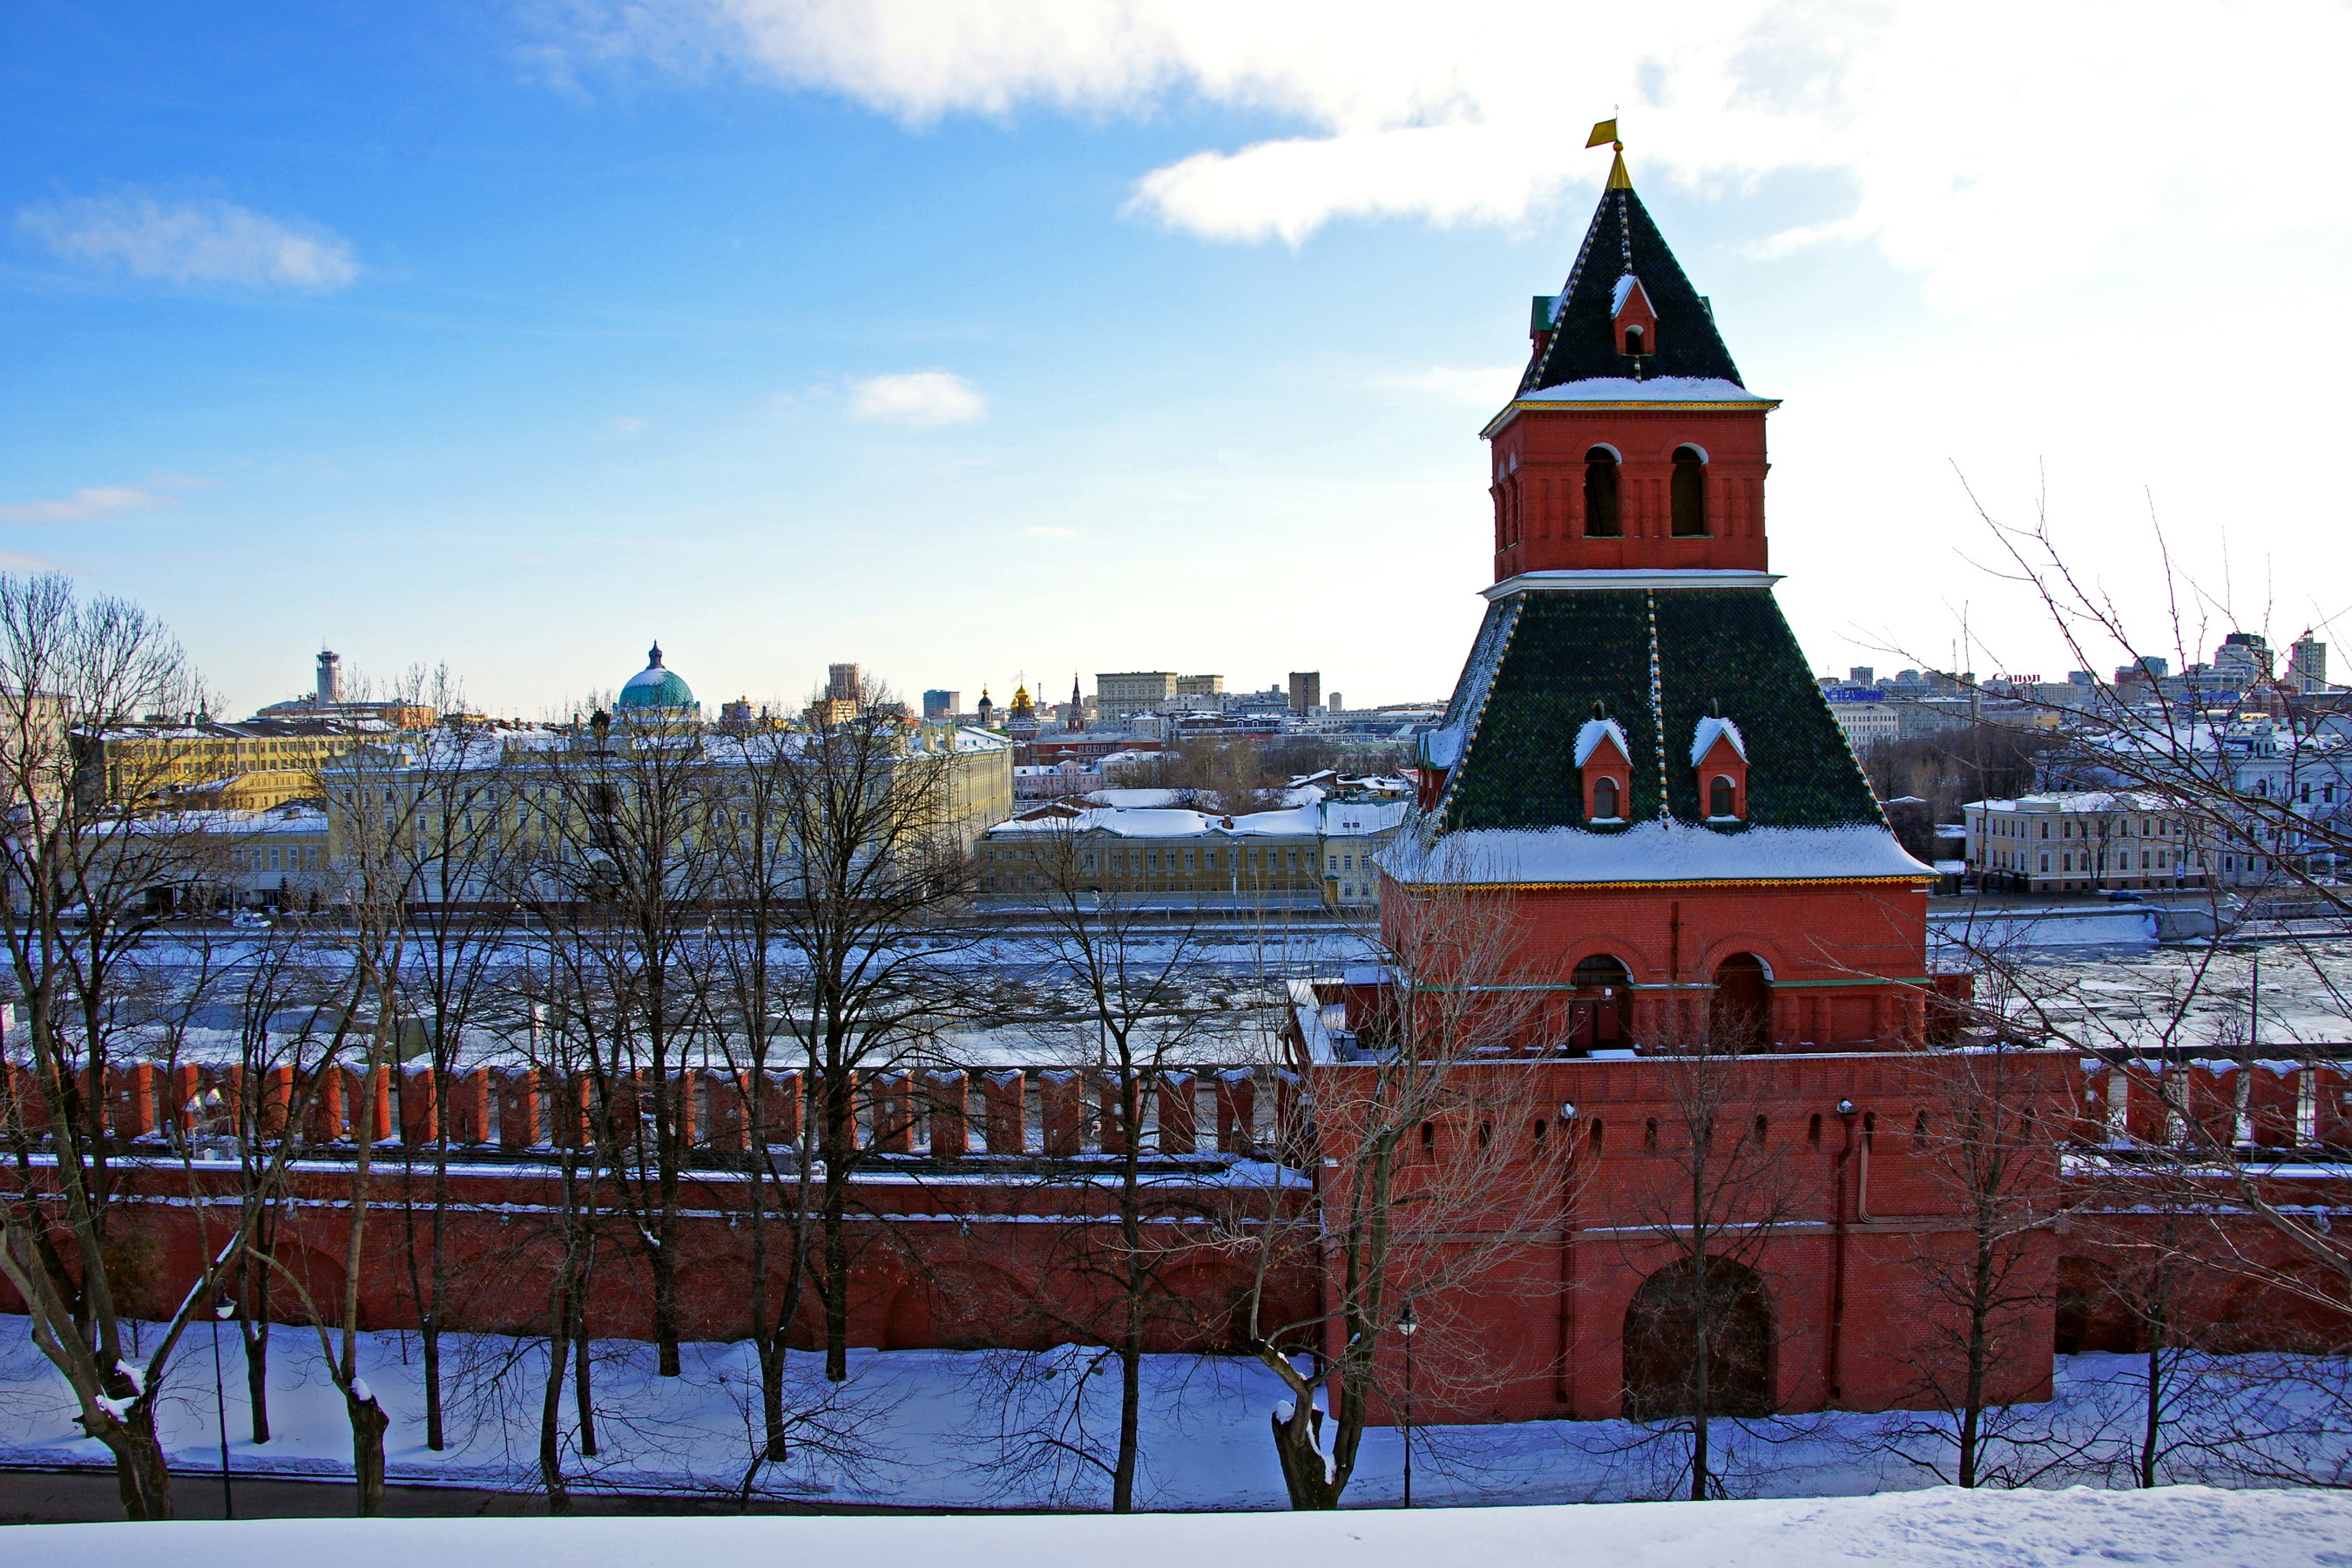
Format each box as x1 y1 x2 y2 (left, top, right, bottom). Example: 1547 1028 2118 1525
17 195 360 294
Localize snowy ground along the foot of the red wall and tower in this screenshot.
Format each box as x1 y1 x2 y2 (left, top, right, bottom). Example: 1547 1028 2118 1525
0 1319 2352 1513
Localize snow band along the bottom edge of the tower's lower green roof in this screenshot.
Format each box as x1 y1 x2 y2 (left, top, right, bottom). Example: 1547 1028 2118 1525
1378 823 1933 884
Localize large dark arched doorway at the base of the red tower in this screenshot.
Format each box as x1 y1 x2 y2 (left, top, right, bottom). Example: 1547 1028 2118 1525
1625 1258 1774 1420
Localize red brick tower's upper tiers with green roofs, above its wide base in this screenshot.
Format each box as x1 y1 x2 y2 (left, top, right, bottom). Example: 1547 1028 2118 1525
1388 162 1929 1051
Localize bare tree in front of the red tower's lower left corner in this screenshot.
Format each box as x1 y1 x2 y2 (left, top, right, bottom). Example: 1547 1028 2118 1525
1220 889 1573 1510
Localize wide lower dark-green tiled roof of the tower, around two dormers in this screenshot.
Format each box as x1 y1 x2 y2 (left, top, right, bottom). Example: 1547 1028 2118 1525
1439 588 1884 832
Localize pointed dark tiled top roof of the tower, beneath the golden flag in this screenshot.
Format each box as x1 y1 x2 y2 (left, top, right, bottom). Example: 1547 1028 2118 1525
1519 188 1745 393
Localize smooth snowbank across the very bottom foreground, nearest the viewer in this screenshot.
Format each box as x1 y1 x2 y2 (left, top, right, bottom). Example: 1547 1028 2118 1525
18 1486 2352 1568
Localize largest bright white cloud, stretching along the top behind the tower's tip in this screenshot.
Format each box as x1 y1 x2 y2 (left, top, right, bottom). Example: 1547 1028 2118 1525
567 0 2352 308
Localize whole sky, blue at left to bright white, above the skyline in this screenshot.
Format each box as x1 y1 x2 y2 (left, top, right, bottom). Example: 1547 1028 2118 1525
13 0 2352 714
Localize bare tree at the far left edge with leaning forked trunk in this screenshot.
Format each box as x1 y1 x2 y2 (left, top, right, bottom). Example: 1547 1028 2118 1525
0 573 245 1518
